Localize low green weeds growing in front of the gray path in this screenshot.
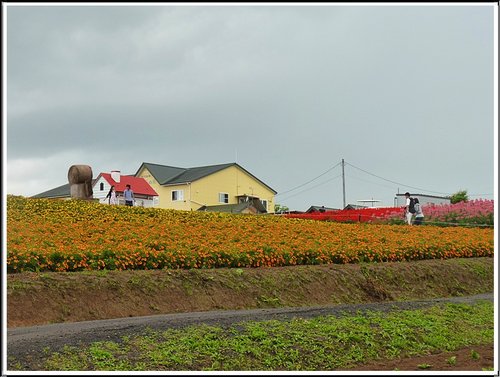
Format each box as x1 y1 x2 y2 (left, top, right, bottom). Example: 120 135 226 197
10 302 494 371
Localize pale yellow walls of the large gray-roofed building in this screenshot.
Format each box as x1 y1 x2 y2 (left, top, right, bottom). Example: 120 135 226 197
138 166 274 213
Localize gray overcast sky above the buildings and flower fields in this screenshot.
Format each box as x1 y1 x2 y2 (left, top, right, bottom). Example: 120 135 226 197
2 3 497 210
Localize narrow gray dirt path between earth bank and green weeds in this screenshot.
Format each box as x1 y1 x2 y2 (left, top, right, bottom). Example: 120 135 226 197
7 293 494 369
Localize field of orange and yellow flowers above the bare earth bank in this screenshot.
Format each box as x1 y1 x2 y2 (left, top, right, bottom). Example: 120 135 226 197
7 195 494 273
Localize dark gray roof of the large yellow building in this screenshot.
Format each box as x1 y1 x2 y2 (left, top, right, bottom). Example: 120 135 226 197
135 162 277 194
